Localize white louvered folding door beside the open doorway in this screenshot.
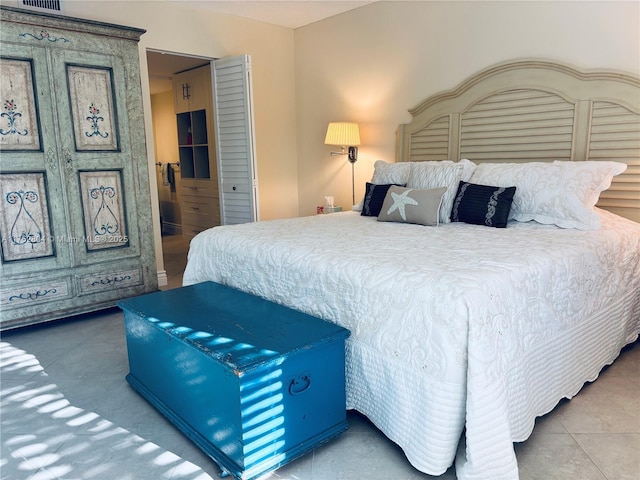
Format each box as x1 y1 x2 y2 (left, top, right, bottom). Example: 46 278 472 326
213 55 258 225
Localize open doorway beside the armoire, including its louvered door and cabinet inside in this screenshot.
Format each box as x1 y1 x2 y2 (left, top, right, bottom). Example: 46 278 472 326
147 51 259 284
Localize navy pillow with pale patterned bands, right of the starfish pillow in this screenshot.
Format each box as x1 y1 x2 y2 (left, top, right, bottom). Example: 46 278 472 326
451 182 516 228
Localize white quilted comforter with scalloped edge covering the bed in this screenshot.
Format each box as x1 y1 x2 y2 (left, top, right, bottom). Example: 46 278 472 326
184 211 640 480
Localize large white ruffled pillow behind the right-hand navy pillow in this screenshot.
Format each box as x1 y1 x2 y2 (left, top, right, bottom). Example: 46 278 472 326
471 161 627 230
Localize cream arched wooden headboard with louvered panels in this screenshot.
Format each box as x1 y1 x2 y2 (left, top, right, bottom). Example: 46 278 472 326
397 59 640 222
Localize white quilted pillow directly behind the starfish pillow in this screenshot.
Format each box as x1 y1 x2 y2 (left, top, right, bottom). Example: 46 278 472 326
407 160 464 223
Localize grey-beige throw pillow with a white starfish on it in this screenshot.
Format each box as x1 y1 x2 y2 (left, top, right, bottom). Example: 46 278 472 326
378 186 447 226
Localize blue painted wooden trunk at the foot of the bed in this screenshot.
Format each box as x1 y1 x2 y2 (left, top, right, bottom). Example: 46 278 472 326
118 282 349 480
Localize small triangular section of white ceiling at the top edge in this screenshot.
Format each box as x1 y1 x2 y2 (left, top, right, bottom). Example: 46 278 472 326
176 0 376 28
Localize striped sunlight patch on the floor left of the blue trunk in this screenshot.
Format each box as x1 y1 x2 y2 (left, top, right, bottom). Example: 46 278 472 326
0 342 211 480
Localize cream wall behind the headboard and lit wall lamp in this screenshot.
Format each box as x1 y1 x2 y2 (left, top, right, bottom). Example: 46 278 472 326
295 1 640 215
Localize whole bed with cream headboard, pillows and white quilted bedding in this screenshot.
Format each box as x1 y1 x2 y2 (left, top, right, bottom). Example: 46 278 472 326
183 59 640 480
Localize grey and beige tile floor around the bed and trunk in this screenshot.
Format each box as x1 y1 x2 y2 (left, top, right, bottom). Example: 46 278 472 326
0 237 640 480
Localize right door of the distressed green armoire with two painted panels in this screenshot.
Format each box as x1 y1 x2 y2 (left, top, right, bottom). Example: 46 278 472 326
52 50 141 265
